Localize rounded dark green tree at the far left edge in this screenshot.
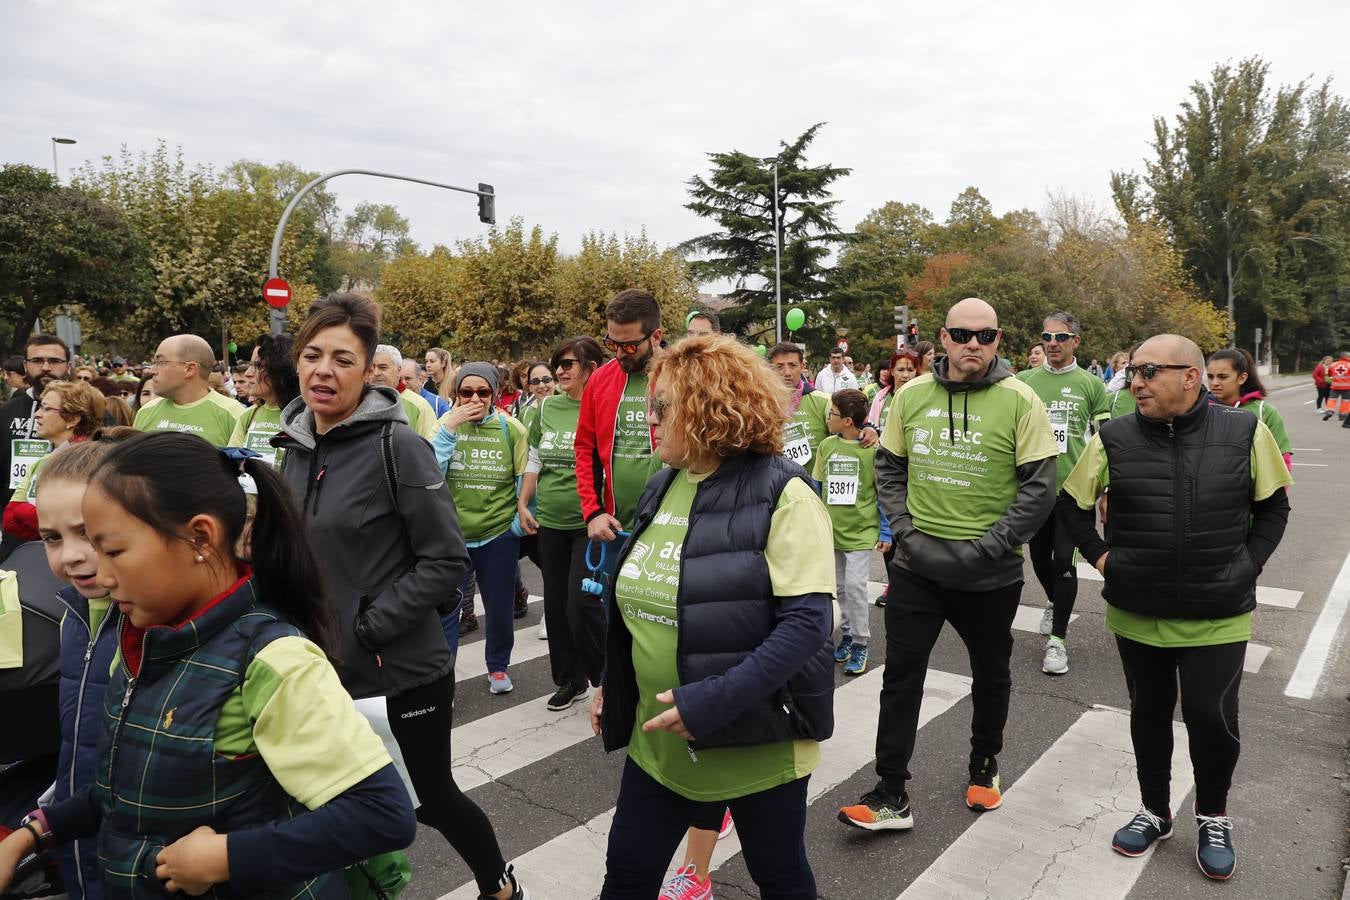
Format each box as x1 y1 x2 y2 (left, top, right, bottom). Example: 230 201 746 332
0 165 150 351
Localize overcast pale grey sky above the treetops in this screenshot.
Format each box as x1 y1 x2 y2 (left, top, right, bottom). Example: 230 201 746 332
0 0 1350 276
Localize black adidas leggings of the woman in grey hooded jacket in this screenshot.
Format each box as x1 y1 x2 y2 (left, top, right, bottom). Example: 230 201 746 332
385 672 509 893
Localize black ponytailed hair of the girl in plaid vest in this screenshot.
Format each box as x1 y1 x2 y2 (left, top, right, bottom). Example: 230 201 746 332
90 432 338 656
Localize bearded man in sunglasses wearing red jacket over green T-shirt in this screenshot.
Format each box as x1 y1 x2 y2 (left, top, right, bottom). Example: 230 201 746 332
574 287 663 542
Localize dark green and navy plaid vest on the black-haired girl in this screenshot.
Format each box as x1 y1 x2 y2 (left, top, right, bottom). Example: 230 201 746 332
93 579 337 900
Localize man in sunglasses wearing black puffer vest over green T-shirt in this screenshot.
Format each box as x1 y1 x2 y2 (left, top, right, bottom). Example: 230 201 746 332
1056 335 1293 881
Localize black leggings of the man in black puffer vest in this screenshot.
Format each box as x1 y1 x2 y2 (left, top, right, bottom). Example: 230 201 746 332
1115 637 1247 818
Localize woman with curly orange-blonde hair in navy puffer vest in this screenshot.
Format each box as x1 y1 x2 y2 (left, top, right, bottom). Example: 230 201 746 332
591 336 834 899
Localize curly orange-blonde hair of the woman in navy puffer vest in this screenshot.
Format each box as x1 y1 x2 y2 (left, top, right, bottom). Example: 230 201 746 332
651 335 788 459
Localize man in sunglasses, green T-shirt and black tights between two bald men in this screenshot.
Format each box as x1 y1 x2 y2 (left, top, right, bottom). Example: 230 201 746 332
1018 312 1111 675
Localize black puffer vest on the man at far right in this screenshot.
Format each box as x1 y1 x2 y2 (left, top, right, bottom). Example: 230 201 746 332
1102 391 1260 619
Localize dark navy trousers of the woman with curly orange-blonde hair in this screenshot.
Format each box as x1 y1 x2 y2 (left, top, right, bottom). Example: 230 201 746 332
599 760 815 900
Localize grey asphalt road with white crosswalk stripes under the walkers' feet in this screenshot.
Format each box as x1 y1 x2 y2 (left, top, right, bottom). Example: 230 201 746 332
404 379 1350 900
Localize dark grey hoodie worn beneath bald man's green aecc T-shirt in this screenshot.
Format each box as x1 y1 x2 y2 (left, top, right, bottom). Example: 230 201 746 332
876 359 1056 591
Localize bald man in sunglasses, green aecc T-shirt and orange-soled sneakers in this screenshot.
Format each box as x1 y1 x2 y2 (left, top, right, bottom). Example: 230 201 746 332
840 297 1057 831
